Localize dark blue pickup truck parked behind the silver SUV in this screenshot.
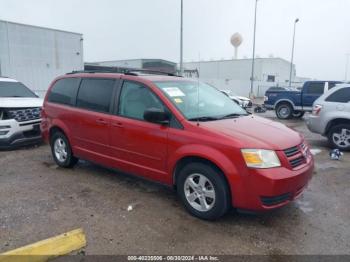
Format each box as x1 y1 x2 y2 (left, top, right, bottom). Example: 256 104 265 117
264 81 341 119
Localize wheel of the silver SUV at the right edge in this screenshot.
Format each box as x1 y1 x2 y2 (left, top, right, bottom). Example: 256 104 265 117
328 124 350 151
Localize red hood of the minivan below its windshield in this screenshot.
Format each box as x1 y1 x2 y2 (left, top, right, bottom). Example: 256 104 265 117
200 115 303 150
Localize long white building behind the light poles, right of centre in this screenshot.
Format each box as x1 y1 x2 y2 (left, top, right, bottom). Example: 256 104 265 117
184 58 302 97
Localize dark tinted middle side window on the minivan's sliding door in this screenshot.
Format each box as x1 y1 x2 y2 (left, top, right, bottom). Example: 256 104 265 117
77 78 115 113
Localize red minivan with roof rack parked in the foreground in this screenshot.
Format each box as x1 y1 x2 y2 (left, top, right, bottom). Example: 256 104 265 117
41 72 314 220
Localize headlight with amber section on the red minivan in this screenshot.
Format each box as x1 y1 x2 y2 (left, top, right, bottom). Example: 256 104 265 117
241 149 281 168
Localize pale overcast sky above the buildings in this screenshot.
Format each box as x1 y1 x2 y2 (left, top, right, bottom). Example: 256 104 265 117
0 0 350 80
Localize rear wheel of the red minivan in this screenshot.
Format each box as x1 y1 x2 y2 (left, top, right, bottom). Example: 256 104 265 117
51 131 78 168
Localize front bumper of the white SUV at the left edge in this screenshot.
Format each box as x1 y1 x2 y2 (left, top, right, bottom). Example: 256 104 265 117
0 119 42 150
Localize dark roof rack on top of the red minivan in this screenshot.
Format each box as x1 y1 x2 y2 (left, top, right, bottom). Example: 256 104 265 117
67 65 181 77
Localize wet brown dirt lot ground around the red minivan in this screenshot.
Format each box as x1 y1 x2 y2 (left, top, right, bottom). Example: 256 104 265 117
0 113 350 255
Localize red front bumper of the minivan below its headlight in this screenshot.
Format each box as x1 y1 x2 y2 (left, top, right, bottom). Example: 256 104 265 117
232 155 314 212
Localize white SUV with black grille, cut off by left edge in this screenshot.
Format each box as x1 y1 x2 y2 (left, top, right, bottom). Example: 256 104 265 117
0 77 43 149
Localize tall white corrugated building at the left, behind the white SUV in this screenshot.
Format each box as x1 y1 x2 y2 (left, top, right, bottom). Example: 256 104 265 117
0 20 84 96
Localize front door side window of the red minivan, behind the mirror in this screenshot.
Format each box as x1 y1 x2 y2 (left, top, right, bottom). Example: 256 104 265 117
118 81 165 120
